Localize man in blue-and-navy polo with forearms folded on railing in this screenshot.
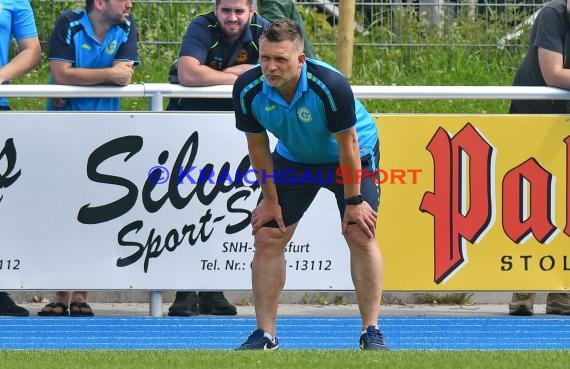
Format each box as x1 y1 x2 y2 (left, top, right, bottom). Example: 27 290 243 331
47 0 139 111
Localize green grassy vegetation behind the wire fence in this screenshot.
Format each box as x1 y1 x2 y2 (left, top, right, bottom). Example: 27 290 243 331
12 0 530 113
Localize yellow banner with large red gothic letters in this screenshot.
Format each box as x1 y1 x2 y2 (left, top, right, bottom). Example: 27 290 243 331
376 115 570 291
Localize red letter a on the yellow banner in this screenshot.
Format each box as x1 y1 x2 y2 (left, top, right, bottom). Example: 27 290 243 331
503 158 556 243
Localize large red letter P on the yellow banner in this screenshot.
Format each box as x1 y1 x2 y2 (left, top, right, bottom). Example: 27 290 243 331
420 123 494 284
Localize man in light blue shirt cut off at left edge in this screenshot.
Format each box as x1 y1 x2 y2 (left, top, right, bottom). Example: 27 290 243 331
0 0 42 316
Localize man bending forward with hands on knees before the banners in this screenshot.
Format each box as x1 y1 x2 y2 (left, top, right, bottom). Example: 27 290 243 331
233 19 387 350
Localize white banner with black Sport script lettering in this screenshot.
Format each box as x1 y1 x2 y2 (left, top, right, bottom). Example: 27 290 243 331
0 112 353 290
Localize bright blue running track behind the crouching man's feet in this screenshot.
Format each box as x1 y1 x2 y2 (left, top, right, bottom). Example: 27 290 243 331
0 316 570 350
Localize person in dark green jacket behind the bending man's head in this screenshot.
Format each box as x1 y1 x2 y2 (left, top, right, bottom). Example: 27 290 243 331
255 0 318 59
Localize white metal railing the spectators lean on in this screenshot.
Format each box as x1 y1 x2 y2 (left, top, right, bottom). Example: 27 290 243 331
0 83 570 317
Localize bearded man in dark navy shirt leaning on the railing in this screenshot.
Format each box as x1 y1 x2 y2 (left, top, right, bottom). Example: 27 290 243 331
168 0 269 111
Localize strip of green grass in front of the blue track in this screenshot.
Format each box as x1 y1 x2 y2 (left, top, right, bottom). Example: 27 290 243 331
0 350 570 369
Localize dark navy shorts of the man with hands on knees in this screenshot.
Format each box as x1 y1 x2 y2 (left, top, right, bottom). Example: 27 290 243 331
259 143 380 228
